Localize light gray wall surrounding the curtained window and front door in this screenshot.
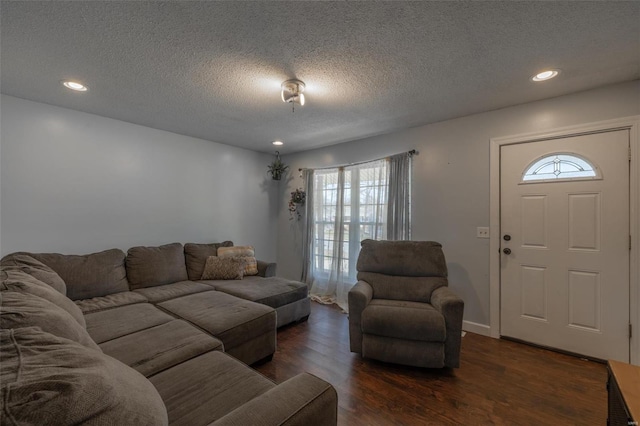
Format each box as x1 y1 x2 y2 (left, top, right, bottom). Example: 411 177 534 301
277 81 640 325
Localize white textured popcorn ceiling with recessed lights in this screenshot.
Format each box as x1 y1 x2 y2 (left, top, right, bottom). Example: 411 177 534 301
0 1 640 153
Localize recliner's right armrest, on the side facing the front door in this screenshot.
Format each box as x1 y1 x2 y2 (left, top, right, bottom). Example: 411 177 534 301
431 287 464 368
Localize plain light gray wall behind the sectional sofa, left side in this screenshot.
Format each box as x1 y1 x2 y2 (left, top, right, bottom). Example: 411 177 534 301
0 95 277 260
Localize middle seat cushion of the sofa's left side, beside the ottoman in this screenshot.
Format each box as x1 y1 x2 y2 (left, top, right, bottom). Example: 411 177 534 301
100 320 224 377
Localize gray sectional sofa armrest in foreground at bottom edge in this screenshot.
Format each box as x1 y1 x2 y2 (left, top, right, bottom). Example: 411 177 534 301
211 373 338 426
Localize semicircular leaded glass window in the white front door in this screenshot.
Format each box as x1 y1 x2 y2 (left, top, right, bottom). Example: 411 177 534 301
521 153 602 183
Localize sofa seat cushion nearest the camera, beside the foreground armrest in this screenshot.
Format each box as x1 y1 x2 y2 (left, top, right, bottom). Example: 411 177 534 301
149 351 275 426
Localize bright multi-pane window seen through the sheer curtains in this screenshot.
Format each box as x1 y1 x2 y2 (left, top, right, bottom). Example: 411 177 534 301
313 160 388 283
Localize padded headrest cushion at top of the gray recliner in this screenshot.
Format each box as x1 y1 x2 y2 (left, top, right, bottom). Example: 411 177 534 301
356 240 447 279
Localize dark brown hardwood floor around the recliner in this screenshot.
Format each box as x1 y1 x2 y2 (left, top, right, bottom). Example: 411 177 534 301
257 303 607 426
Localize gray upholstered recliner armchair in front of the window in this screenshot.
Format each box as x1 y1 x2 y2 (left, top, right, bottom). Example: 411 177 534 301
349 240 464 368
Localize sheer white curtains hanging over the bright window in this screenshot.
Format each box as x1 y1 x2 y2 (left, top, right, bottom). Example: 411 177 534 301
302 154 402 311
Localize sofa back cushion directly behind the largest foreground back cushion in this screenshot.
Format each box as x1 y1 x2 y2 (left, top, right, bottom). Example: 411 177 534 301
0 291 100 352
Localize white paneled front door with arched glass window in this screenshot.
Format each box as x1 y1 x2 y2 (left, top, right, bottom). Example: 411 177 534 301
500 130 630 362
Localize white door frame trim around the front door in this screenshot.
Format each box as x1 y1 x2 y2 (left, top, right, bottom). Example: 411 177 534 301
489 115 640 365
